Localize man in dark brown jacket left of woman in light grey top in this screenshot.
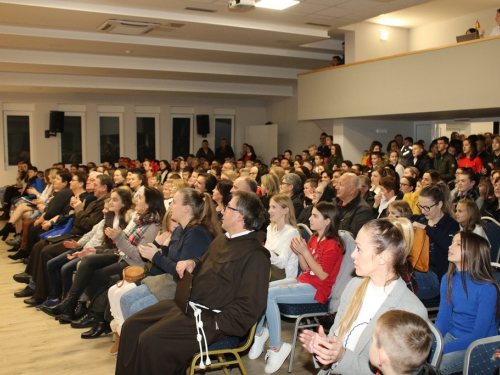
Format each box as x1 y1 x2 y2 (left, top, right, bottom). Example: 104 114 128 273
14 174 113 306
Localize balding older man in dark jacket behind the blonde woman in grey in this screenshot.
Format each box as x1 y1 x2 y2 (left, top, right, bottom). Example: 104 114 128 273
335 173 373 238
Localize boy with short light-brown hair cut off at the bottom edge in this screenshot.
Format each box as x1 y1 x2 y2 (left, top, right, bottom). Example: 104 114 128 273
370 310 442 375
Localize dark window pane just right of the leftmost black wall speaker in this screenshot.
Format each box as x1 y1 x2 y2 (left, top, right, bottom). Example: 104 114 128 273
61 116 82 164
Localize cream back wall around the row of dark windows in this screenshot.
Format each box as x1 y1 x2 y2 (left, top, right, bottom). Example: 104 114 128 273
0 93 270 184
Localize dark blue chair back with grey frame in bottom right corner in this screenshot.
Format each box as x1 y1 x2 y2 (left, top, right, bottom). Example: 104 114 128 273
463 336 500 375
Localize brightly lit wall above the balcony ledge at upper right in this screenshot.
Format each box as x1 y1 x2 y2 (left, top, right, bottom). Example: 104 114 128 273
409 8 498 51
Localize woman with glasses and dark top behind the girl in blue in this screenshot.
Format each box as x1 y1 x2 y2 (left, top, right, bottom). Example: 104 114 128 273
410 183 460 299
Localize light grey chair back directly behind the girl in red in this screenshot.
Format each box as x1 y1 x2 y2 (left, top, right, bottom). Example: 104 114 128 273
328 230 356 313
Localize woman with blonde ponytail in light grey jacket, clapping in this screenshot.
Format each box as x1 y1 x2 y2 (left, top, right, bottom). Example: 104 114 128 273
300 218 427 375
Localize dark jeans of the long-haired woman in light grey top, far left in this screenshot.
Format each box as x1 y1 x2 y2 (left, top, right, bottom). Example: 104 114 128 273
47 248 81 299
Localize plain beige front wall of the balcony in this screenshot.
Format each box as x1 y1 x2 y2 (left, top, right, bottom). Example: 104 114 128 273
298 37 500 121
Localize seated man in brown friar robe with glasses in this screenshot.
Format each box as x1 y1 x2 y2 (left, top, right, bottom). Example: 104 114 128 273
116 191 270 375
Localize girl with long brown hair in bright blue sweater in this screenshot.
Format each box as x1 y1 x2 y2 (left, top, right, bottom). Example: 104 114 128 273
436 232 500 374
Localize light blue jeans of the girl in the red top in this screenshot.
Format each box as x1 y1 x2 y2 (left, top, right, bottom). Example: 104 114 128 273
256 279 318 347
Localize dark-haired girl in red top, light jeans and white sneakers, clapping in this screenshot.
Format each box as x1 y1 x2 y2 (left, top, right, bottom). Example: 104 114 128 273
248 202 345 374
